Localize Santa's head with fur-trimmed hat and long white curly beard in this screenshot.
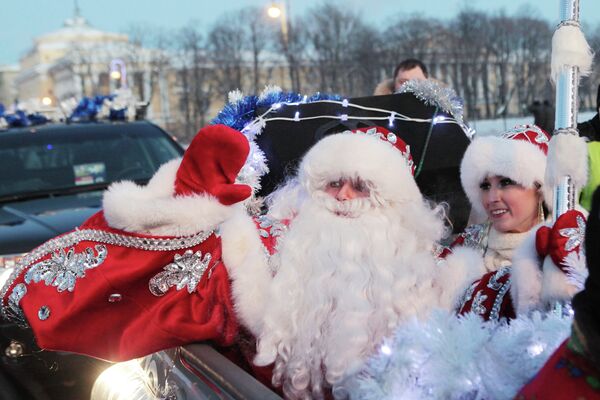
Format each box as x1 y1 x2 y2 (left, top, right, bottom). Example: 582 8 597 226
241 127 444 398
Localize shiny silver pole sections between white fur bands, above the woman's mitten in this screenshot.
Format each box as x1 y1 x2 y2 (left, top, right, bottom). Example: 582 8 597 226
553 0 579 221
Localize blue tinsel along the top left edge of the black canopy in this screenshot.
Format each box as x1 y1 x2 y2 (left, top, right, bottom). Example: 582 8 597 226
210 91 342 131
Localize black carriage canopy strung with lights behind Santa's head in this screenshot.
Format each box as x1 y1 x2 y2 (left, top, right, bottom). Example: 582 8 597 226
256 92 470 233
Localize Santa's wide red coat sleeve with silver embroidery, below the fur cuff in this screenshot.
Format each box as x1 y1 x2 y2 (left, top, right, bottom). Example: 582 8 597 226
2 212 238 361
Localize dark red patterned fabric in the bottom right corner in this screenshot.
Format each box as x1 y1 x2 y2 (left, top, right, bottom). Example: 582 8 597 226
515 340 600 400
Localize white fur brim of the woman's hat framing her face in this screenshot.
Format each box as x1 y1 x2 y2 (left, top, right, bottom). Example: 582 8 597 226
460 136 548 220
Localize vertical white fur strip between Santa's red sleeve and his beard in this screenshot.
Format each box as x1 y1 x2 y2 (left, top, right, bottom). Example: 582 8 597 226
220 209 272 335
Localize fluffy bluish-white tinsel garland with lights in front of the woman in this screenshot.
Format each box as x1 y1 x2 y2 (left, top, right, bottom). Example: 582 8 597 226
334 310 572 400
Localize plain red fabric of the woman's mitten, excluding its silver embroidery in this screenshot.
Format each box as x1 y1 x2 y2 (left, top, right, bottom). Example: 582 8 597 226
535 210 585 271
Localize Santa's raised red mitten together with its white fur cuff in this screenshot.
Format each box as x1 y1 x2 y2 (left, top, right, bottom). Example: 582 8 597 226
103 125 252 236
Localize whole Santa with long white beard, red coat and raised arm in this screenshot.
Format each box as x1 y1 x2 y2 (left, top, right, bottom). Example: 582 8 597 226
1 126 444 398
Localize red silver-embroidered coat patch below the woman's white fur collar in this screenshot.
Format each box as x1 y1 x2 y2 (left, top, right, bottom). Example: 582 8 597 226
458 270 516 321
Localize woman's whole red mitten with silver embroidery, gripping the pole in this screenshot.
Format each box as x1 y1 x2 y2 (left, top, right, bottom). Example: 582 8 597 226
535 210 586 273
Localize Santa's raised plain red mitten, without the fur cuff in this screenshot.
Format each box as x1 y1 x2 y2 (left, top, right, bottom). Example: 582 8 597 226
175 125 252 205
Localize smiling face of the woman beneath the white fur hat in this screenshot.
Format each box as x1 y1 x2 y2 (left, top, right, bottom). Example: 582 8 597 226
479 175 540 233
